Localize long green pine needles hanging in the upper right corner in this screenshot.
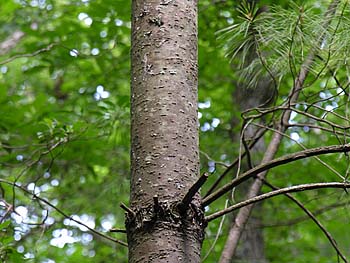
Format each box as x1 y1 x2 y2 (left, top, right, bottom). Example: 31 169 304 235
218 1 350 88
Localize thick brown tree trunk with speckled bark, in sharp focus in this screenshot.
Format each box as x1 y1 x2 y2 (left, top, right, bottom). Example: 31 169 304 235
126 0 204 263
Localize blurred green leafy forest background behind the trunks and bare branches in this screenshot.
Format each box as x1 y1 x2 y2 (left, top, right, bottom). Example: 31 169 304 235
0 0 350 263
